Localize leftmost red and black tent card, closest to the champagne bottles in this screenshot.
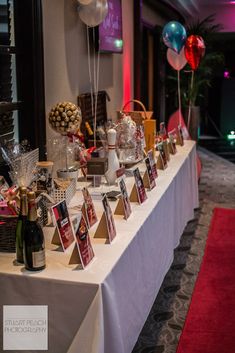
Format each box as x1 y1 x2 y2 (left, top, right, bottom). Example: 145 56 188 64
51 200 74 251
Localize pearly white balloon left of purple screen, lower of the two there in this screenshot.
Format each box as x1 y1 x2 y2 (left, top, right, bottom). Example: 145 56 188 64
78 0 108 27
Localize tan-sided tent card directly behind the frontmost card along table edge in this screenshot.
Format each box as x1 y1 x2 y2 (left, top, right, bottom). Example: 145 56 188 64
94 195 117 243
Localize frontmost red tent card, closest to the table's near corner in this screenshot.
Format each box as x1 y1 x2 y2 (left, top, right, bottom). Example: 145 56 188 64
69 214 95 268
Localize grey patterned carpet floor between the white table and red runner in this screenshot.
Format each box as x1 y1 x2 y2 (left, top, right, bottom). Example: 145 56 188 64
132 149 235 353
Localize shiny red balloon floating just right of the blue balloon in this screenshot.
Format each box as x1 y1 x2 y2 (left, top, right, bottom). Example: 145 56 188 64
184 35 206 70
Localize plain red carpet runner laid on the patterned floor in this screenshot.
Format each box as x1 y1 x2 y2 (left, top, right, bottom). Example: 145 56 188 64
177 208 235 353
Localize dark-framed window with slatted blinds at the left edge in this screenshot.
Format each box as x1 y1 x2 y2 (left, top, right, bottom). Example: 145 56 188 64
0 0 46 182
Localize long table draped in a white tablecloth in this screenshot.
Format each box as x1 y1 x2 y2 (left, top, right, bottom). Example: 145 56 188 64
0 141 198 353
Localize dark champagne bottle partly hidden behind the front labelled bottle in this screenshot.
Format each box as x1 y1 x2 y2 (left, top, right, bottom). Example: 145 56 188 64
16 187 28 263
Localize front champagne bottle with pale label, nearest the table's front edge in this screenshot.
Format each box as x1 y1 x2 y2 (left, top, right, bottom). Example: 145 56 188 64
24 192 46 271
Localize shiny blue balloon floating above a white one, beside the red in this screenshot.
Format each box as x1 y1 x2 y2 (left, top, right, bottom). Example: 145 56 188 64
162 21 187 53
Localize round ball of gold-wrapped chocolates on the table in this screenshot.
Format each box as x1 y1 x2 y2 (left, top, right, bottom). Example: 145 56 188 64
49 102 82 135
